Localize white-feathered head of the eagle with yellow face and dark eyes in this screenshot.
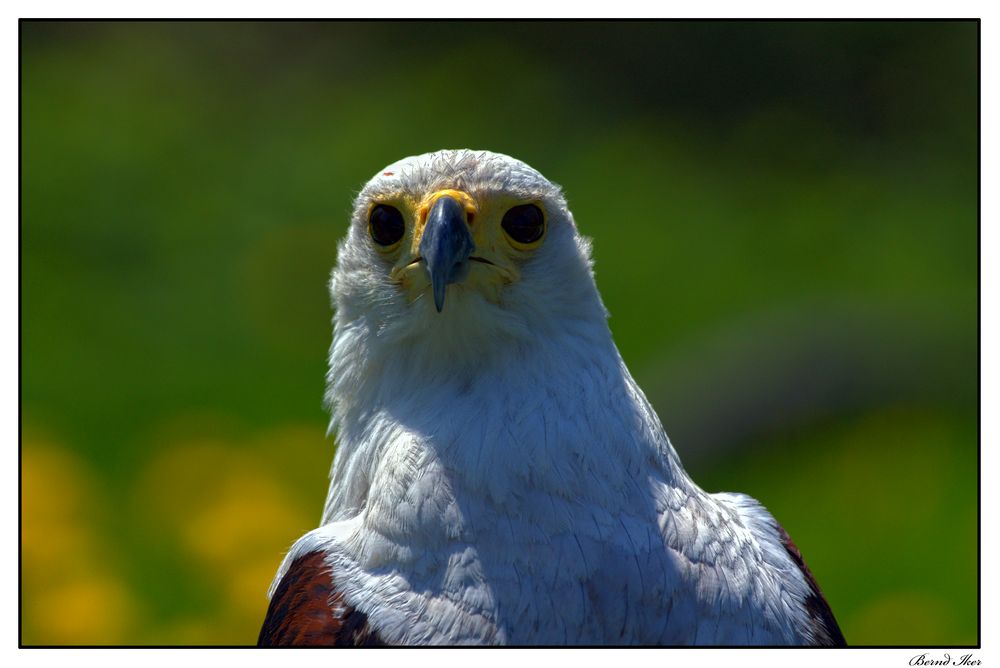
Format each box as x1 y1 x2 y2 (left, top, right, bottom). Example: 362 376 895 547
331 150 606 370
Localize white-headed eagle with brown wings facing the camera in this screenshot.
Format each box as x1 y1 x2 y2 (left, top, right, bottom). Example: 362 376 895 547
258 150 844 646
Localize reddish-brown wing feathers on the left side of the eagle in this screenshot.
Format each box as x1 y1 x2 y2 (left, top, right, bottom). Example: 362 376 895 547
257 552 383 647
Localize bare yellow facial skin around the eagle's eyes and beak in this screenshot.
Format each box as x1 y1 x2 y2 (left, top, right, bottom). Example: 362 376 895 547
376 189 548 302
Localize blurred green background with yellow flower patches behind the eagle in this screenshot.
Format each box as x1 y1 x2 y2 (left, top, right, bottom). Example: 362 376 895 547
21 22 979 645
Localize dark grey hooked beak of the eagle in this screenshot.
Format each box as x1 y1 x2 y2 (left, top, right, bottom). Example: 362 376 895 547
420 195 476 313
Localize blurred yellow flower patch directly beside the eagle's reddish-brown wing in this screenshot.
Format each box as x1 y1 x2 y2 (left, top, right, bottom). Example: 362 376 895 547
133 419 331 644
